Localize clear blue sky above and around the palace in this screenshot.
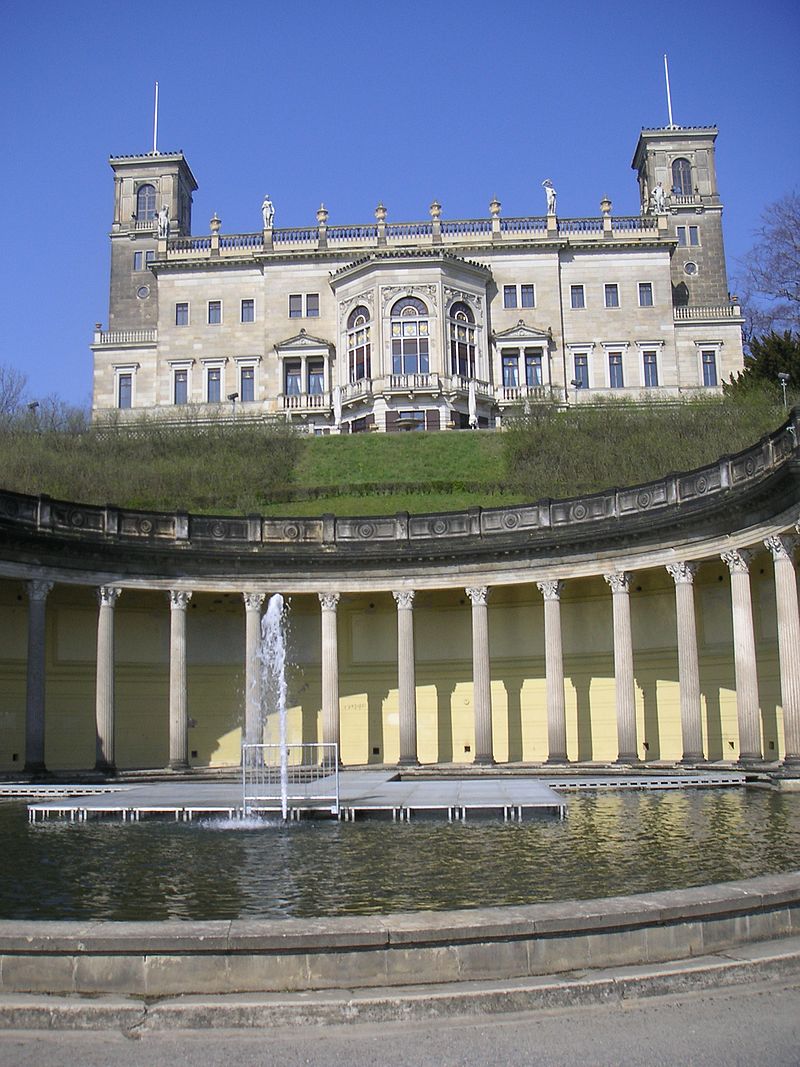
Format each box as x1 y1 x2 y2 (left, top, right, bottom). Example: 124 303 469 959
0 0 800 403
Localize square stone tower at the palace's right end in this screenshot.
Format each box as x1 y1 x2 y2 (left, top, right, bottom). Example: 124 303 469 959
631 126 729 306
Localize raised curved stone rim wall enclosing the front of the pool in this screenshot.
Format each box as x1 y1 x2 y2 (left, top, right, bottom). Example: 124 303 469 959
0 872 800 999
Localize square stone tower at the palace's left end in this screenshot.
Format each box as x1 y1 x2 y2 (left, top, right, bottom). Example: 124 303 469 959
109 152 197 330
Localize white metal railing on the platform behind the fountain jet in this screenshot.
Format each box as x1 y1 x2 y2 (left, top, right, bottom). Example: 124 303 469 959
237 742 339 818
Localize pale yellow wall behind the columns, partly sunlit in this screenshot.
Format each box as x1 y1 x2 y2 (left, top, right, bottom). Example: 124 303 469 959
0 553 783 770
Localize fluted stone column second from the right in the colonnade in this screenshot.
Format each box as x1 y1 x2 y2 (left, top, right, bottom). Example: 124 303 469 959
722 550 762 762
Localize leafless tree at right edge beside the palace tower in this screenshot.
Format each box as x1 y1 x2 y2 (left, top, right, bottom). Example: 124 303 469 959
739 192 800 340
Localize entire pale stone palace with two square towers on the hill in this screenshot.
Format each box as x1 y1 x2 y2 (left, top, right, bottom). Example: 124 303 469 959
92 126 742 433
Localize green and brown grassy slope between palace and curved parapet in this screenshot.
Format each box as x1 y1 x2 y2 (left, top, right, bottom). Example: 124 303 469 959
0 396 784 515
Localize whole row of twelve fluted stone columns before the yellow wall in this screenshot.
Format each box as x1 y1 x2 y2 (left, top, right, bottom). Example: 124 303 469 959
17 534 800 773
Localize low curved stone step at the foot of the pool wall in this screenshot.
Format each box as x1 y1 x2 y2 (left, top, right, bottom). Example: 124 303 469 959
0 938 800 1032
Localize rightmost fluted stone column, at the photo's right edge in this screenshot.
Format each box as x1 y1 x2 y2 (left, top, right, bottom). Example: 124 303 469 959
764 534 800 766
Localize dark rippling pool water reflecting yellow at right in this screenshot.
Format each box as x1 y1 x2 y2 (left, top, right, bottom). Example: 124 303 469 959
0 790 800 920
